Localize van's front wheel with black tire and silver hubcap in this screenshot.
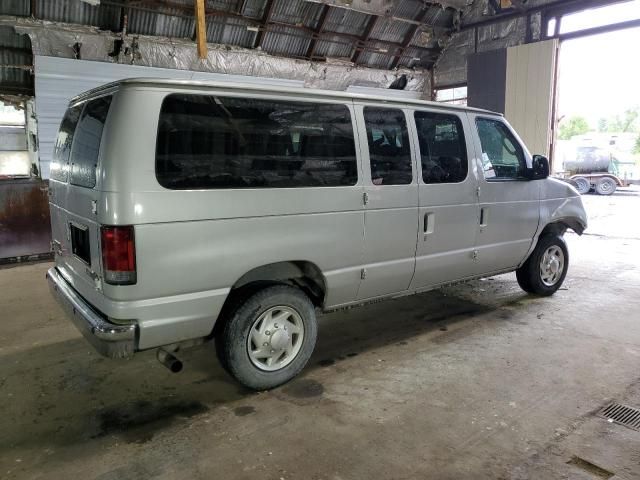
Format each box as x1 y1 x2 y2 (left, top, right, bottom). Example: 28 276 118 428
516 235 569 296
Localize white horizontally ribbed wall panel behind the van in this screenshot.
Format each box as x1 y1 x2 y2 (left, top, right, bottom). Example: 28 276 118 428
34 55 304 178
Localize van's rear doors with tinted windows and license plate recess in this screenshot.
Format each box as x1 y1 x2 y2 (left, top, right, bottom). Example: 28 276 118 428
49 95 113 296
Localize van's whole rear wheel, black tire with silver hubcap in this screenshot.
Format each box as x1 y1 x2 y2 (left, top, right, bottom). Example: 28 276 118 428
216 285 318 390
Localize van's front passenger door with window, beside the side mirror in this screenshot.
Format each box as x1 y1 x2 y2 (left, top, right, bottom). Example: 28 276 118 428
470 114 540 274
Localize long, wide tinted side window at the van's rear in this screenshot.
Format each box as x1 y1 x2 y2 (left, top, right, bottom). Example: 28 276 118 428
156 94 358 190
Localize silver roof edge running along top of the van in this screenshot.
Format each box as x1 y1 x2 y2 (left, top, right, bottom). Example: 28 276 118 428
70 78 502 115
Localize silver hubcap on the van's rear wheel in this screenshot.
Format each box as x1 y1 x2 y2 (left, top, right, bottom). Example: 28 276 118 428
247 305 304 372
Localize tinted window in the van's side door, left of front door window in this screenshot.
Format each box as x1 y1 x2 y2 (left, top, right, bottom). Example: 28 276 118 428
414 112 469 183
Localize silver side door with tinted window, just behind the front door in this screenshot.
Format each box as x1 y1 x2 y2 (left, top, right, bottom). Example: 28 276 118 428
411 110 478 290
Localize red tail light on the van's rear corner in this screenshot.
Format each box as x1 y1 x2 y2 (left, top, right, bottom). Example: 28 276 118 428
101 225 137 285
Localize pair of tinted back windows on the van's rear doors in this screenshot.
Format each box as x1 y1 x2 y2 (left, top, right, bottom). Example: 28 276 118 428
51 96 112 188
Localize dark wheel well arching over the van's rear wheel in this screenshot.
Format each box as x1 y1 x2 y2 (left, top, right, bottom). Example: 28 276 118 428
214 260 327 335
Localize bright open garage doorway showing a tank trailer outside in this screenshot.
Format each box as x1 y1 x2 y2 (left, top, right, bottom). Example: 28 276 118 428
548 0 640 195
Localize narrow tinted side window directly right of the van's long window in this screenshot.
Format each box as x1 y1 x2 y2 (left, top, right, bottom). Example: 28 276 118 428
364 107 413 185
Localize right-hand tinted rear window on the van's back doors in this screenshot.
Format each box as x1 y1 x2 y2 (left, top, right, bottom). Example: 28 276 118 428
70 96 112 188
